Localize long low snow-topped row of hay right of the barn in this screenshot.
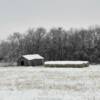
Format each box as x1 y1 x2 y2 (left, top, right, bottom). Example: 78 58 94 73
44 61 89 68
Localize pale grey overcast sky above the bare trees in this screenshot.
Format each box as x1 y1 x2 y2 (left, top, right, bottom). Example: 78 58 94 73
0 0 100 39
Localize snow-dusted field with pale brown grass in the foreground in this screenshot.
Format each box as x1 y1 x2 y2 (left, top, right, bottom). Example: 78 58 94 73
0 65 100 100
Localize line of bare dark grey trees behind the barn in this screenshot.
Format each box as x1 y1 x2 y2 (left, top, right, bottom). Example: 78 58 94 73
0 27 100 63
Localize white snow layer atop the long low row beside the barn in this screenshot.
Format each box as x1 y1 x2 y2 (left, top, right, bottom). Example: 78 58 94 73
45 61 88 65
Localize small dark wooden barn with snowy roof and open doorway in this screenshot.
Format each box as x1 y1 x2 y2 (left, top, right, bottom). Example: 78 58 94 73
17 54 44 66
